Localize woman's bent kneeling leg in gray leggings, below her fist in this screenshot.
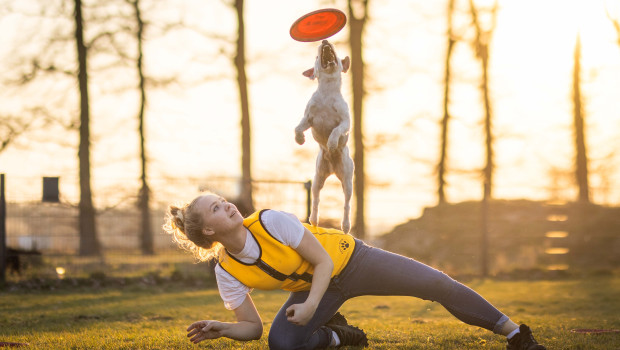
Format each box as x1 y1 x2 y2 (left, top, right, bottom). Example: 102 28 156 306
269 286 345 350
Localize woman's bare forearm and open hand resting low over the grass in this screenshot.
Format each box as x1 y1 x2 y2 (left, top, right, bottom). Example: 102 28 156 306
187 294 263 344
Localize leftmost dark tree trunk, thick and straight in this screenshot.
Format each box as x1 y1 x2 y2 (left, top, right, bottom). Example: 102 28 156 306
74 0 101 255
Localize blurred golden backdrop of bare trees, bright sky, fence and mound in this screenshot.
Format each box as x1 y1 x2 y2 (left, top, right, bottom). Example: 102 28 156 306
0 0 620 280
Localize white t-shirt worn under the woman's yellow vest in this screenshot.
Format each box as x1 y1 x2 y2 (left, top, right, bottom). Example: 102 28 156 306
215 210 304 310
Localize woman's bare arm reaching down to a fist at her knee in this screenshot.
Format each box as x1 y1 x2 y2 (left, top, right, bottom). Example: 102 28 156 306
286 227 334 326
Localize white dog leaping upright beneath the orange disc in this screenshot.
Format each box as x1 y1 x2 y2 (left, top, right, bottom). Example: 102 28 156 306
295 40 354 233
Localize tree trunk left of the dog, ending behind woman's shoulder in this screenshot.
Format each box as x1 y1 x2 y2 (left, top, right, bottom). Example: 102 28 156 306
235 0 254 215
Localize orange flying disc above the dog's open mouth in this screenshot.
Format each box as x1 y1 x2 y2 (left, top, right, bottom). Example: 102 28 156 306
290 8 347 42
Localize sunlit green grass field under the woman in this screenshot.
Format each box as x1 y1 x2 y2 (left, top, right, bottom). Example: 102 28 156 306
0 275 620 350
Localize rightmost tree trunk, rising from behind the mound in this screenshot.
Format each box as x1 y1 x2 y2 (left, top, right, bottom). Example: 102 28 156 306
573 34 590 203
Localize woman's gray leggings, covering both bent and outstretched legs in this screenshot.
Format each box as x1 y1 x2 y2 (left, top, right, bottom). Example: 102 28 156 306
269 240 508 350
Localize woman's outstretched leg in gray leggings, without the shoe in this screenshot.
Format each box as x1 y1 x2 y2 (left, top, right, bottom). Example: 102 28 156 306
334 241 509 333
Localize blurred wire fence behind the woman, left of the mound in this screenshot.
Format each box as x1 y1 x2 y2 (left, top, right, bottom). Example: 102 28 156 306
0 174 338 279
